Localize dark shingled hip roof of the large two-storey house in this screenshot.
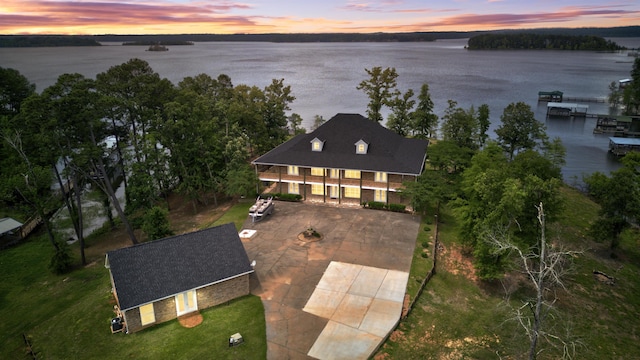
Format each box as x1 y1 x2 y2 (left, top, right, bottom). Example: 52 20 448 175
253 114 429 175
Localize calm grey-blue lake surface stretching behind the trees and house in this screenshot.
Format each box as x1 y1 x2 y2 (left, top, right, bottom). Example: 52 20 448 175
0 38 640 183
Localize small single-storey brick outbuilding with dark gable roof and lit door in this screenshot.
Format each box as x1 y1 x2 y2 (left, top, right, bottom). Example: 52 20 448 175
105 223 253 333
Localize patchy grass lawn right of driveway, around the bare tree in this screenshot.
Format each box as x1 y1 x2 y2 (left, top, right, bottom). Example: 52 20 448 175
378 188 640 359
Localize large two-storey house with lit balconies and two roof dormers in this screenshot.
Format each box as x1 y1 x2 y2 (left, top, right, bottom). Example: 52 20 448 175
252 114 429 204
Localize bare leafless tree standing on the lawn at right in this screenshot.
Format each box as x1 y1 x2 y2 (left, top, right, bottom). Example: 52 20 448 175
486 203 582 360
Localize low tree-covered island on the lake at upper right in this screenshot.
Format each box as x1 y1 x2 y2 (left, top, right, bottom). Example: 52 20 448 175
467 32 625 51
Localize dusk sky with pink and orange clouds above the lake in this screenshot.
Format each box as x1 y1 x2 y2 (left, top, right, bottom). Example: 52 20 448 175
0 0 640 34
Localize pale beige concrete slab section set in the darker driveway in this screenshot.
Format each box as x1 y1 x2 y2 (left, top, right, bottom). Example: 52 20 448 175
303 261 409 359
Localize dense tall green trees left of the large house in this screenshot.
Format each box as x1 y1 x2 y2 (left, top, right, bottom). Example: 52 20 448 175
0 59 300 272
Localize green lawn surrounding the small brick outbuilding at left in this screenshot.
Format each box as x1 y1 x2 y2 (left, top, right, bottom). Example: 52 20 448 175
0 204 267 359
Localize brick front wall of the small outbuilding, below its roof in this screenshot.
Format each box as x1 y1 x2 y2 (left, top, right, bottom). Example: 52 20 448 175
125 274 250 333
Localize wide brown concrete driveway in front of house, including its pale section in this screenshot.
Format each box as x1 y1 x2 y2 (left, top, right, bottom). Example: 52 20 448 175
242 202 420 359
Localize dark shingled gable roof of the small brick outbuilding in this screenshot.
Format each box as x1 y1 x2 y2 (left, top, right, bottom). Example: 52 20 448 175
107 223 253 310
